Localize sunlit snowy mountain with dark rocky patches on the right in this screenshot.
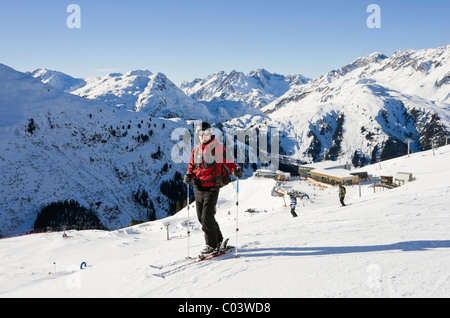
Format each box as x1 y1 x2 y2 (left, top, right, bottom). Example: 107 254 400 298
256 45 450 164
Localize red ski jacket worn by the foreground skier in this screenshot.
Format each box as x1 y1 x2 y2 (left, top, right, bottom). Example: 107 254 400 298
187 136 237 188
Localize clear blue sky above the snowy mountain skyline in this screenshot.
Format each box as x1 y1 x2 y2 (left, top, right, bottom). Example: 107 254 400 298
0 0 450 83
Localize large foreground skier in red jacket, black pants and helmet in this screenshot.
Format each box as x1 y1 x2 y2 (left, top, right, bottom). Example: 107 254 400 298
184 123 242 254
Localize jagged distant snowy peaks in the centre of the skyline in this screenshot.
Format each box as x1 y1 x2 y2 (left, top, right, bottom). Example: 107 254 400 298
180 69 309 108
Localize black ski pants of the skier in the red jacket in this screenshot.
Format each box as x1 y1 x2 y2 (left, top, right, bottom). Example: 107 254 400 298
195 188 223 248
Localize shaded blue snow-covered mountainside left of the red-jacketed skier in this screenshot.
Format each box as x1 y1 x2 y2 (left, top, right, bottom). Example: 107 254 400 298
0 65 193 235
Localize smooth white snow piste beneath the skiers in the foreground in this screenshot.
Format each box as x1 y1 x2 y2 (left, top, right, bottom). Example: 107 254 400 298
0 146 450 298
